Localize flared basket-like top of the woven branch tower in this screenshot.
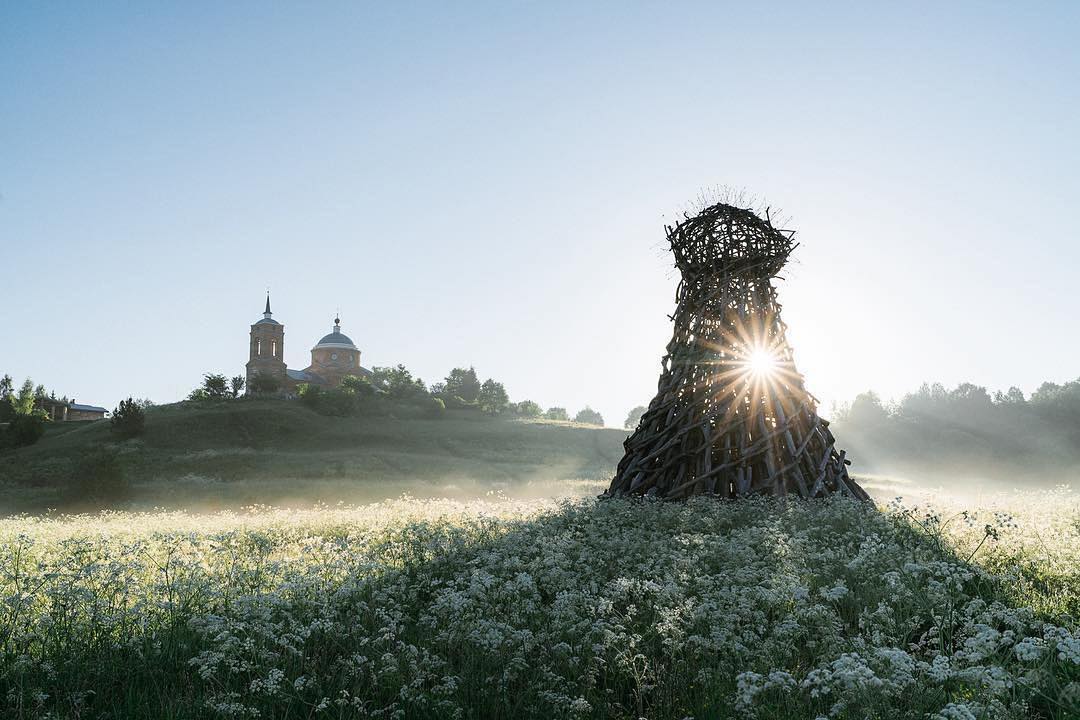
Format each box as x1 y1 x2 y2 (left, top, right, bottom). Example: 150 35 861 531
666 203 797 277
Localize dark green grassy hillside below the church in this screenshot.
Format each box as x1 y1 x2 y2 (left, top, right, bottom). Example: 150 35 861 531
0 400 625 513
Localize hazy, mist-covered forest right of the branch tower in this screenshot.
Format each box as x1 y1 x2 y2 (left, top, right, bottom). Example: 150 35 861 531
833 379 1080 485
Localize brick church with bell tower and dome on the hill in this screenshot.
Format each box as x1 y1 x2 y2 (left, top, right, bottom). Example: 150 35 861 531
247 293 372 395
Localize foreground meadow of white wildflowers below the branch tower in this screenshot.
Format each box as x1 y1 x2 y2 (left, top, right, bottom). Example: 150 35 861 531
0 490 1080 720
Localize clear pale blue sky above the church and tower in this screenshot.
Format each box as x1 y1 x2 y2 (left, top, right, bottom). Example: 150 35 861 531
0 2 1080 424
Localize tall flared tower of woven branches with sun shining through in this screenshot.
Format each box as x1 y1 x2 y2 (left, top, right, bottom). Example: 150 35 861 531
602 203 869 500
